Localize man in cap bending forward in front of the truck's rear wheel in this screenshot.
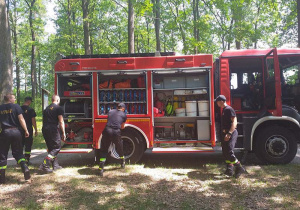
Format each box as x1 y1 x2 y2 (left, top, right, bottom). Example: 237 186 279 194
99 103 127 176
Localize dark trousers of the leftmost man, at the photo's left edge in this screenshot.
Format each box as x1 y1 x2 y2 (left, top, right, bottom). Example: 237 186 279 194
0 128 24 167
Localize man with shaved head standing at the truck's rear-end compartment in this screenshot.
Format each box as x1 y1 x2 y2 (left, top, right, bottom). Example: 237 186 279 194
40 95 66 173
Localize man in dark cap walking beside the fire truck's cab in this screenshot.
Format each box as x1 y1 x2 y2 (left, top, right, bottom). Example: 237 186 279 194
215 95 245 178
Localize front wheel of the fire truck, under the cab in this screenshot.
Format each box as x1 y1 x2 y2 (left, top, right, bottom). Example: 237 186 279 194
254 126 297 164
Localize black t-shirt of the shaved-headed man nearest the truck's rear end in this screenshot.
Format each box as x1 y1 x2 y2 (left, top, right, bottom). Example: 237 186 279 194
43 104 64 125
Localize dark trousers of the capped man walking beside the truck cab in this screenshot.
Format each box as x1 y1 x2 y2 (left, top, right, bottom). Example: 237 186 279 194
221 130 238 163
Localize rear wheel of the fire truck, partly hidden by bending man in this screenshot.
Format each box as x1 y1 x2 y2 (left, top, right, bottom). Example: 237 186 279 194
108 129 146 163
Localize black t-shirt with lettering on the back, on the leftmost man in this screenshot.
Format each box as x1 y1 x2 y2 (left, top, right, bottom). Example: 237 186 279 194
0 103 23 130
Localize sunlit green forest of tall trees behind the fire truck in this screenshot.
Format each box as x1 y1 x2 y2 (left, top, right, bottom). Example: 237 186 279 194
0 0 300 113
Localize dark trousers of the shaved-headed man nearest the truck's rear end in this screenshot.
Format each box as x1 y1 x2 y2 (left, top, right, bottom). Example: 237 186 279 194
42 125 61 157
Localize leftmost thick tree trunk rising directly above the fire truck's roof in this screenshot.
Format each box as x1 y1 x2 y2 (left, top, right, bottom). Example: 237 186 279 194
82 0 91 55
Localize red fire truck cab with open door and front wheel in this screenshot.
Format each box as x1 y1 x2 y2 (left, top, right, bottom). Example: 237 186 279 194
214 48 300 164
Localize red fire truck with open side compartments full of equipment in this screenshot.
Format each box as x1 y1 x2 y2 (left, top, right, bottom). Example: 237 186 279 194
55 49 300 163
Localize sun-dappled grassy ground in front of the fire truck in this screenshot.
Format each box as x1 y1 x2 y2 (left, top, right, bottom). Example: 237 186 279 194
0 117 300 210
